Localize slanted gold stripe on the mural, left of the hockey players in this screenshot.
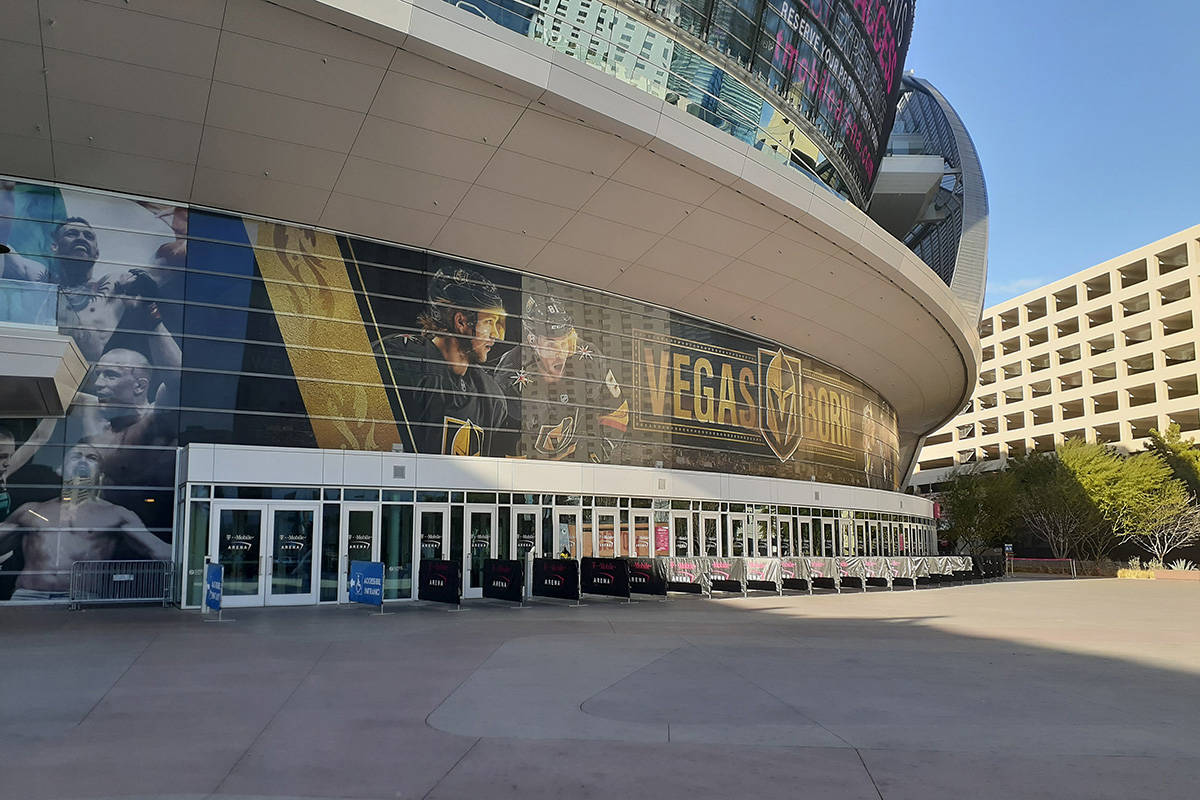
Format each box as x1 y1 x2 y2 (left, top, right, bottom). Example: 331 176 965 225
247 222 401 450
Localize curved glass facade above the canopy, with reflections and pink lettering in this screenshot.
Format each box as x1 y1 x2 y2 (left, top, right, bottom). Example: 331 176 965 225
448 0 913 205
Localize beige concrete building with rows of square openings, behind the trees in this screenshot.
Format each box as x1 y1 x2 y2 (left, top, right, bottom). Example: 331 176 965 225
912 227 1200 493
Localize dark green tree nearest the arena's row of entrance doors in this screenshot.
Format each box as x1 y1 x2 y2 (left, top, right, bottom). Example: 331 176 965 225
938 469 1015 555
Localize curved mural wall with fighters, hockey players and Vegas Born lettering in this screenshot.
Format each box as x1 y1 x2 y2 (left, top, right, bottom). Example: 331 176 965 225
0 181 898 601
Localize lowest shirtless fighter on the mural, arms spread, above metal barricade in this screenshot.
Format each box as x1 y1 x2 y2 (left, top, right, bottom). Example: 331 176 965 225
0 441 170 602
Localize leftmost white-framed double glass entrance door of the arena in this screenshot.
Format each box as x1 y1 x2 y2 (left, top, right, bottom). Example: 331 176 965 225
209 503 320 608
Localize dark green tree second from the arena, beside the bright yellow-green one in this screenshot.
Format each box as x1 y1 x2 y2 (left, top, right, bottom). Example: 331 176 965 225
1009 453 1112 559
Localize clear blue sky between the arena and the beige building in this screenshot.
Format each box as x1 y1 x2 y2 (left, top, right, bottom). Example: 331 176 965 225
906 0 1200 305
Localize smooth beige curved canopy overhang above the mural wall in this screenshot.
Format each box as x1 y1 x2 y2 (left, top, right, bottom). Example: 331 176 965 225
0 0 979 459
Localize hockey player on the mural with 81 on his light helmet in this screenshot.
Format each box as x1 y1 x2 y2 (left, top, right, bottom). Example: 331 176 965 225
496 295 629 464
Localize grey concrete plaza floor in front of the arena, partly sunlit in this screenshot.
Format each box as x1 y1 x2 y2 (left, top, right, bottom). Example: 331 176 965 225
0 579 1200 800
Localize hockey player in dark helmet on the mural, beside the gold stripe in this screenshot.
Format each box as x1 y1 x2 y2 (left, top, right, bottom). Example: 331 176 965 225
374 267 508 456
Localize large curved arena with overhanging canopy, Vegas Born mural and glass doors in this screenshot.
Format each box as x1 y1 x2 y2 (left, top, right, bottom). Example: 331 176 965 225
0 0 978 607
